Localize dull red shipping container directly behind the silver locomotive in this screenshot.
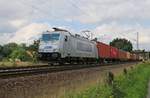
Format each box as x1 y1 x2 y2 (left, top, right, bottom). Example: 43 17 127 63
97 42 110 59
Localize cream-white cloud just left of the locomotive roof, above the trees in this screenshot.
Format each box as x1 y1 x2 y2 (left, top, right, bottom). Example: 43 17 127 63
8 23 50 44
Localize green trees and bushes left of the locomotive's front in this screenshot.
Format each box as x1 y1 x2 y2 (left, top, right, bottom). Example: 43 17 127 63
0 41 39 61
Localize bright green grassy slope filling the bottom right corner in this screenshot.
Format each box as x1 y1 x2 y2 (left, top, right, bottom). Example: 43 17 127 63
65 63 150 98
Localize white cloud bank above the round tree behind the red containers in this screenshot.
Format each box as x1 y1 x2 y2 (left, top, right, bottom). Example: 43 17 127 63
92 23 150 50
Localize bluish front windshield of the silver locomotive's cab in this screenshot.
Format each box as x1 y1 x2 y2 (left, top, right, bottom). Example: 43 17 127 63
42 33 60 41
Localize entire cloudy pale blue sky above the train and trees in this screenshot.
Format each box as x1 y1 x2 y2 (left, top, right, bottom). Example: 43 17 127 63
0 0 150 50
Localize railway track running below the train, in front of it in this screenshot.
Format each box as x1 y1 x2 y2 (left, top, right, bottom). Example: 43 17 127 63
0 62 137 78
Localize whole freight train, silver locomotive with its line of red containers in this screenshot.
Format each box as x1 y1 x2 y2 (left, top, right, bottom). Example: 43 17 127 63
38 28 139 64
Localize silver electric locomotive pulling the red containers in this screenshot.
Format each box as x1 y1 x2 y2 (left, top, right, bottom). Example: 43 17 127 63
38 30 98 62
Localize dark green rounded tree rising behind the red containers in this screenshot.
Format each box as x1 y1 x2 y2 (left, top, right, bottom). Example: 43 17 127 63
110 38 133 52
